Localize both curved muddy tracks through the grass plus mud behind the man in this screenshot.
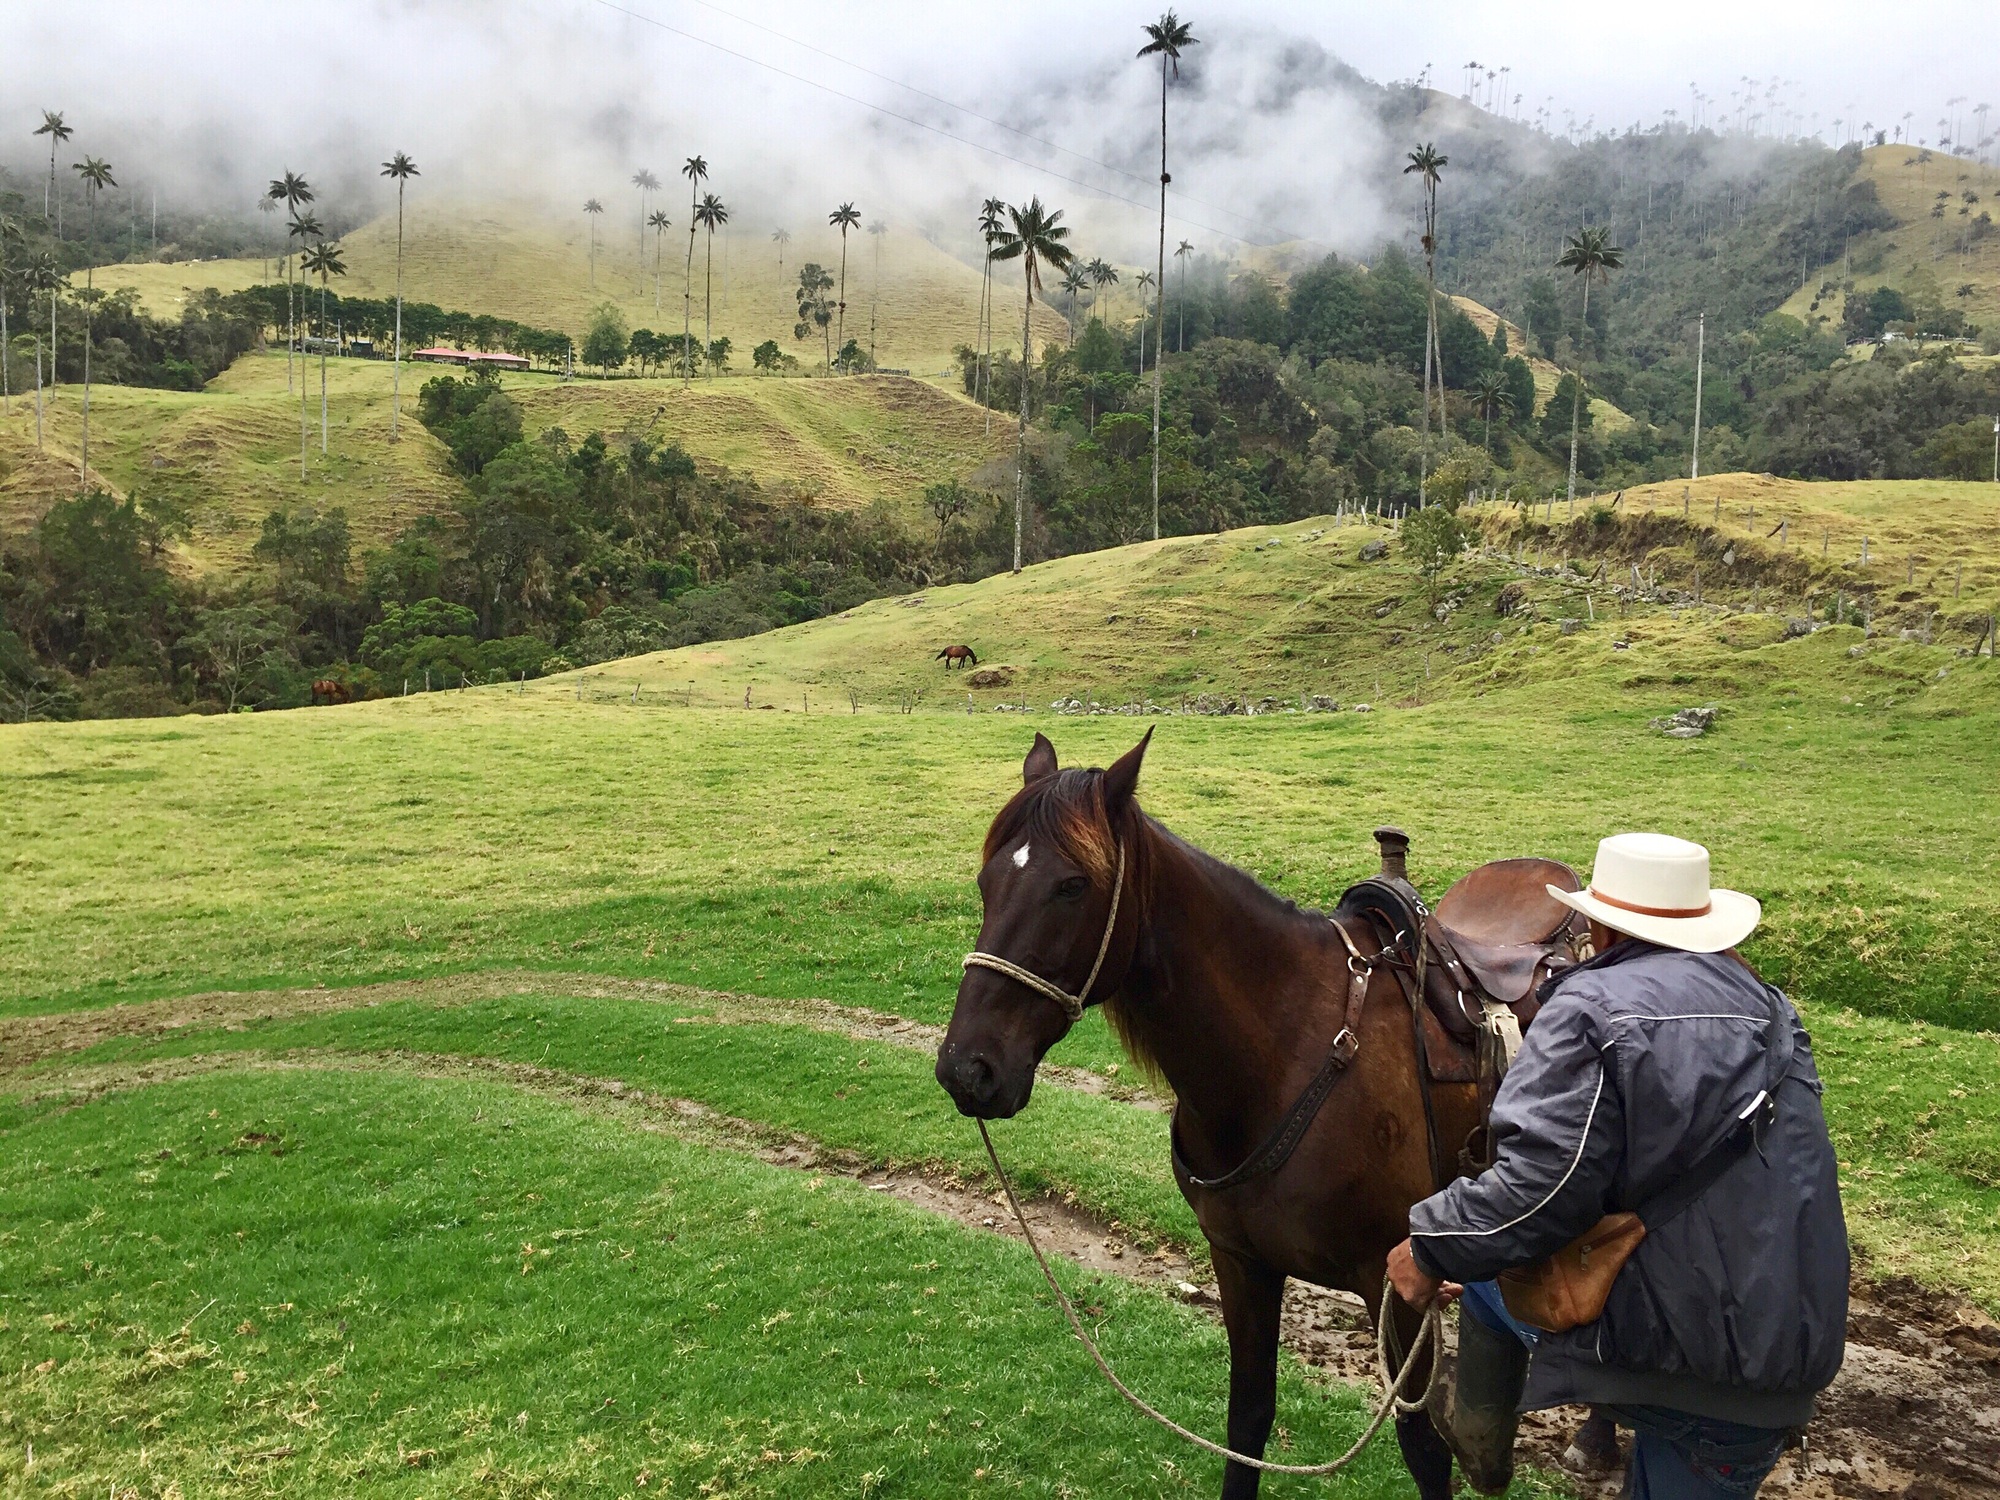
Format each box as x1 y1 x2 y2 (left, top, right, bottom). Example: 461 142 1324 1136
0 974 2000 1500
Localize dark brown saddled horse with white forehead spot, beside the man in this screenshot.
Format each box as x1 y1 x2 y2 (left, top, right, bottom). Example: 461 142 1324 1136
938 732 1478 1500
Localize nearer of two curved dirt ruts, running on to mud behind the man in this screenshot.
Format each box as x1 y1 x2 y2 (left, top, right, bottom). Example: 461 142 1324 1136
19 1048 2000 1500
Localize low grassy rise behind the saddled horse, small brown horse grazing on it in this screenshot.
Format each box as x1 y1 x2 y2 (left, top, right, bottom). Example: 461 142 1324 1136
548 474 2000 712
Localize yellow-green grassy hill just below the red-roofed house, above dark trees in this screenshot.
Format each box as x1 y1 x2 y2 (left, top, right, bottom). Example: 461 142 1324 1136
0 354 1012 570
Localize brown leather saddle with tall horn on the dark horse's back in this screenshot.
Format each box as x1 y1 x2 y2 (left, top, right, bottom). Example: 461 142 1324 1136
1336 828 1590 1172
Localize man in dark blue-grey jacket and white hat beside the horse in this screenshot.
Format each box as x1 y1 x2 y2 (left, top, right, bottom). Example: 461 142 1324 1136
1390 834 1848 1500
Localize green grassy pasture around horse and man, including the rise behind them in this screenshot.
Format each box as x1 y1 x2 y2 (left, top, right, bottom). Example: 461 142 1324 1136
0 502 2000 1496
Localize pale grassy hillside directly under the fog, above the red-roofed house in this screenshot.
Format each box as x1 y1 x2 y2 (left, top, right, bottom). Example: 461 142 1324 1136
80 194 1064 376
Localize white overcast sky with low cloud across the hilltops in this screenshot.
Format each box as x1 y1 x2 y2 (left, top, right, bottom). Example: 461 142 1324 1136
0 0 2000 258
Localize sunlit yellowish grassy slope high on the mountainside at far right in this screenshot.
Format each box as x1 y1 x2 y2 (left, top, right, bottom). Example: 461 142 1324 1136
1782 146 2000 332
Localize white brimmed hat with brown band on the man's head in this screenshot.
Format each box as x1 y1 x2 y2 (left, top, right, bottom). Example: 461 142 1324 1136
1548 834 1764 954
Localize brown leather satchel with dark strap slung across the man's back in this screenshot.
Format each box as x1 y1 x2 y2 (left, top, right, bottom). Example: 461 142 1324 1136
1498 984 1784 1334
